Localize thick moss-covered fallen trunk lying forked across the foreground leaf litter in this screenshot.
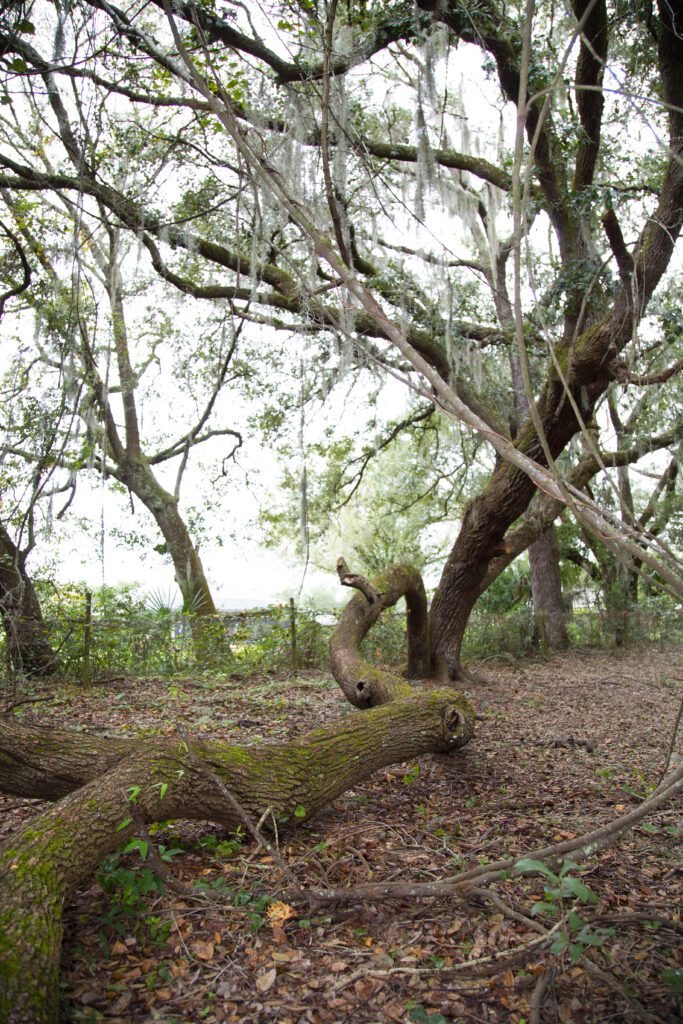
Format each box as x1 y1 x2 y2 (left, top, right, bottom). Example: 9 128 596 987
0 566 474 1024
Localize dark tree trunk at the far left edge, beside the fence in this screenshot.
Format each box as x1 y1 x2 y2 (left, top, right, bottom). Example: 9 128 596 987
0 524 58 676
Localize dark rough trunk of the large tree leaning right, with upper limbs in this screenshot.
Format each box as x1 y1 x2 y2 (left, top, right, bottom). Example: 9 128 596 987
428 0 683 679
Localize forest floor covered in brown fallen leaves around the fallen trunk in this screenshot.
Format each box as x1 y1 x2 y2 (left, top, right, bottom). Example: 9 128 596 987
0 645 683 1024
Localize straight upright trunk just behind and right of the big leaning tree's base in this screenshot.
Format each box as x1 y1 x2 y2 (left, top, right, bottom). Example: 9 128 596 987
528 525 569 650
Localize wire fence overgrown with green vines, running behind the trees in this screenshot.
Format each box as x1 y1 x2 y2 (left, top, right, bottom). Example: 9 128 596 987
0 592 683 686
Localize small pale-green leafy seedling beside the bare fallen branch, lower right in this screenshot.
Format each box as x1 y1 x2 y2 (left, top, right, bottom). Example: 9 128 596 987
515 857 614 964
